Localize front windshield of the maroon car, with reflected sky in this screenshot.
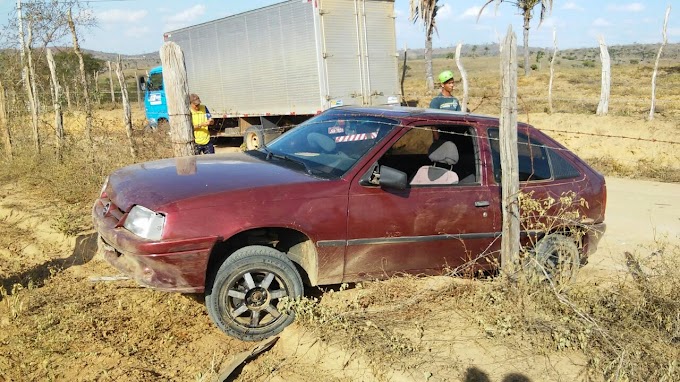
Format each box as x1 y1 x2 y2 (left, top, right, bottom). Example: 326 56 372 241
260 110 398 178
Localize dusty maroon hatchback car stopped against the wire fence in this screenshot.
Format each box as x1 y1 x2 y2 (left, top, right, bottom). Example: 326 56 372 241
92 107 606 340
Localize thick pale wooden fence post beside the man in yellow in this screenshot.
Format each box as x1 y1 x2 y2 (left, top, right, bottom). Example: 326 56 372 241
160 41 194 157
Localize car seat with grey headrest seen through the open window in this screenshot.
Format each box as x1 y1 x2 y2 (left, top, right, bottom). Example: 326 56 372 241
411 141 459 186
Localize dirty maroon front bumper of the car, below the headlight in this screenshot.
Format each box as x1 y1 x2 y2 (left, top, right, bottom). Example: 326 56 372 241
92 200 217 293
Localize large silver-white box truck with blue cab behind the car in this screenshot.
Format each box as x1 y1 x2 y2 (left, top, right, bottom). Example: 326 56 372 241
146 0 402 149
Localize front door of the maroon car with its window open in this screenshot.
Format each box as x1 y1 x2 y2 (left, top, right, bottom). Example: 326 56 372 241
344 126 500 281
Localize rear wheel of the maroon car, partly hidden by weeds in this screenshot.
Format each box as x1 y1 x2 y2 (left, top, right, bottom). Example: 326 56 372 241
529 234 581 285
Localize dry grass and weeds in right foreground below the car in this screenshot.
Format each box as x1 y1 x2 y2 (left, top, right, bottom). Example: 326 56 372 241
274 247 680 381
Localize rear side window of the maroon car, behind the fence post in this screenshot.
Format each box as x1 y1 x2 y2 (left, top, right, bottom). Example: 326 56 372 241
489 129 579 183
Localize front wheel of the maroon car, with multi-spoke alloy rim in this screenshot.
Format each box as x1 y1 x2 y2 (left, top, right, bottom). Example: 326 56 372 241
205 245 303 341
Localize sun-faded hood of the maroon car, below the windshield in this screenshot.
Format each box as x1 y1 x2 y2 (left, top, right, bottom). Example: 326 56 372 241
105 153 323 211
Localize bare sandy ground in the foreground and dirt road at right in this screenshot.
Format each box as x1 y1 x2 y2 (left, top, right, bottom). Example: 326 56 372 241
0 178 680 381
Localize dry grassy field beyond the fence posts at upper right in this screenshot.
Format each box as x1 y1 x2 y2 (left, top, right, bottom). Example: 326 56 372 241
400 57 680 118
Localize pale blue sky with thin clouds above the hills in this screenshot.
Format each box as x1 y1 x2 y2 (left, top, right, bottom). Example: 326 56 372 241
0 0 680 54
